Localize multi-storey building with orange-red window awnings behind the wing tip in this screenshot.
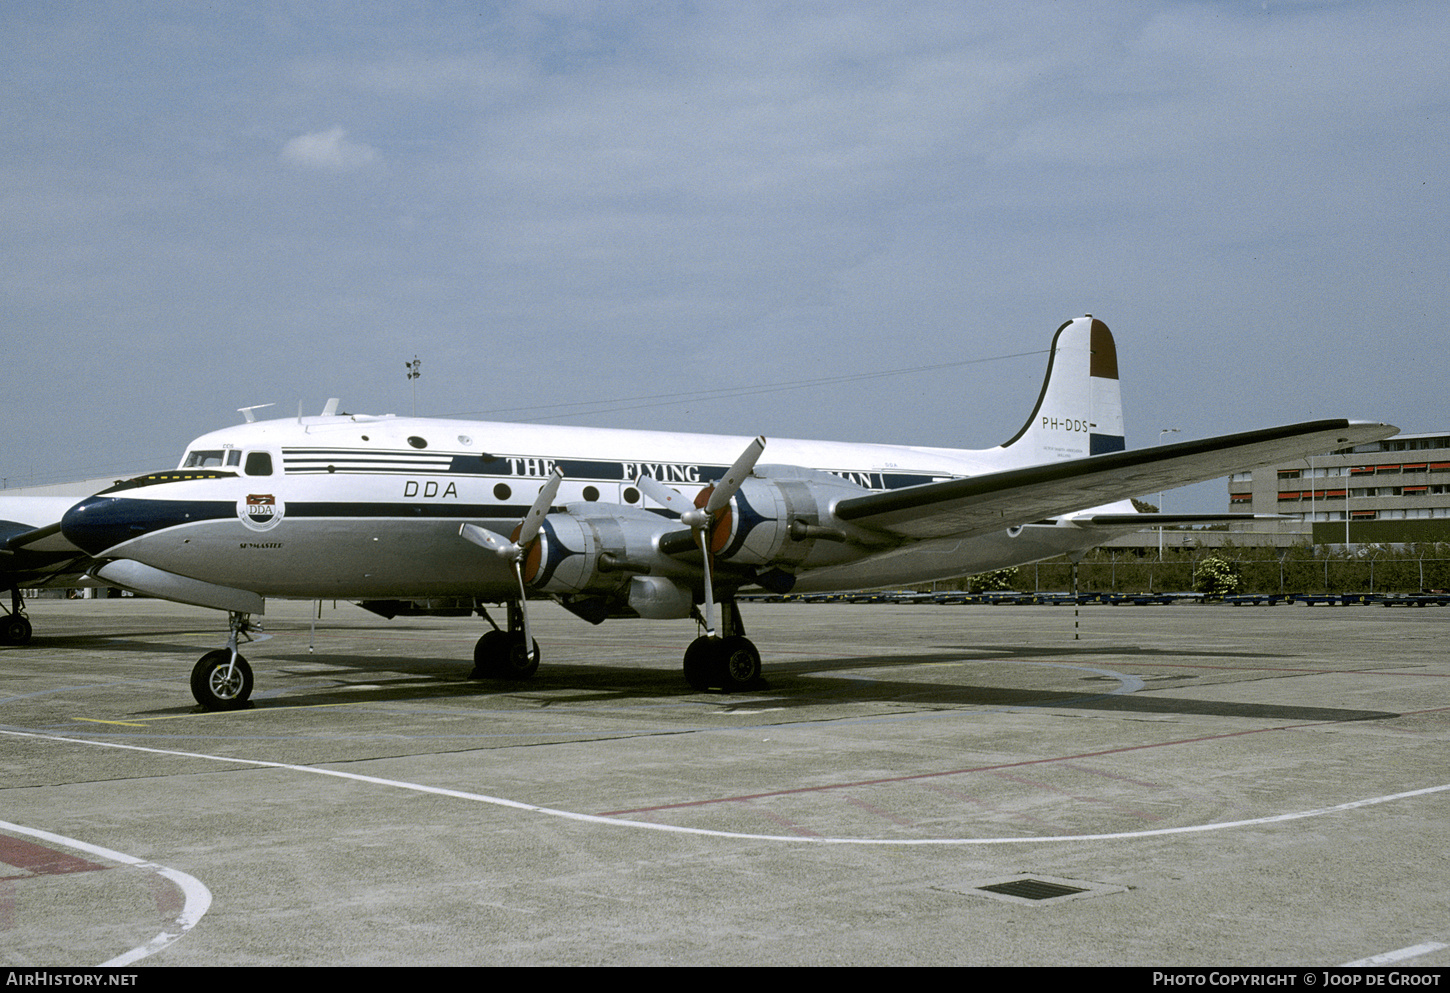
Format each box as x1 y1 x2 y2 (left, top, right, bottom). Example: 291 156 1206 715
1228 433 1450 545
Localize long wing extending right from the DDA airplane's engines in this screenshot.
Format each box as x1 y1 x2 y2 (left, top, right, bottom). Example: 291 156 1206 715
835 420 1399 539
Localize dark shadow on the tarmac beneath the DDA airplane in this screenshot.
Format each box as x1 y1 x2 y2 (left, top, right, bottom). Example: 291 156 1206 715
76 642 1399 723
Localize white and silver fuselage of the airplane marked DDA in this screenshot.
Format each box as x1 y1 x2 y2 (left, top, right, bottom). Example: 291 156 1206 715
65 415 1119 600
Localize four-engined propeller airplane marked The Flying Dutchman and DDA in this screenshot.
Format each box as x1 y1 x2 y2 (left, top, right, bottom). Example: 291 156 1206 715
51 315 1398 709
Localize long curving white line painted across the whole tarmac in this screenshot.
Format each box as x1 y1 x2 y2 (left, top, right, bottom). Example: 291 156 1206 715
11 731 1450 847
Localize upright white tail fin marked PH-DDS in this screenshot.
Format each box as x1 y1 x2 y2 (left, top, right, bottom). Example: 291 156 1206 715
999 315 1127 465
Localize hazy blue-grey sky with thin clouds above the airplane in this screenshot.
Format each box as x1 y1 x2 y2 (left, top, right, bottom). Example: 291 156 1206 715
0 0 1450 510
